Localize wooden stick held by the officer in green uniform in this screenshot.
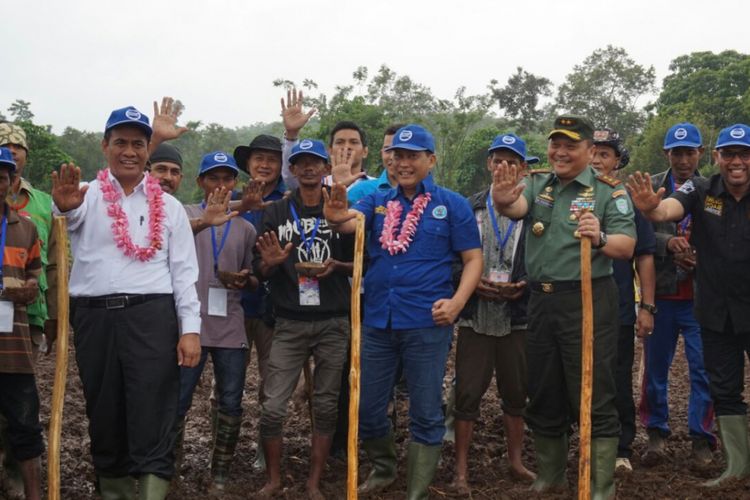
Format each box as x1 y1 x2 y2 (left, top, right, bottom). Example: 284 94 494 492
578 237 594 500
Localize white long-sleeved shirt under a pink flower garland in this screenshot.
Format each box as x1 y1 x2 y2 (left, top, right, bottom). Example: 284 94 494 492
54 173 201 333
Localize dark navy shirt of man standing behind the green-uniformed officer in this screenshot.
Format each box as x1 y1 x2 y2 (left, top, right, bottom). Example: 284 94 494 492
612 207 656 326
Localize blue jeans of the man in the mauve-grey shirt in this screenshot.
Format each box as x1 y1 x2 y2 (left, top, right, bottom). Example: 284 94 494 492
177 347 247 417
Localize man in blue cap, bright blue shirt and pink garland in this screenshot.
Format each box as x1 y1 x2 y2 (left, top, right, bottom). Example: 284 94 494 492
325 125 482 500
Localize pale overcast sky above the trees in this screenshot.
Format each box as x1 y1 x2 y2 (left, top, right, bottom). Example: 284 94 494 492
0 0 750 133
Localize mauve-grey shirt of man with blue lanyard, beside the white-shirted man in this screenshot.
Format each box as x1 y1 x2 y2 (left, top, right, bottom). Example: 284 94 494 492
185 205 255 349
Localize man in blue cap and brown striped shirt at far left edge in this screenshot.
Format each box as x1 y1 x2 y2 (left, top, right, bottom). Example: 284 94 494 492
0 147 44 500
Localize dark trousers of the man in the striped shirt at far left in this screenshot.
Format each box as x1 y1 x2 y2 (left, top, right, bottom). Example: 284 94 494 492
0 373 44 462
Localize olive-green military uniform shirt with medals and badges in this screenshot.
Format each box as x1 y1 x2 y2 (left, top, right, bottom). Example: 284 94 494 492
523 166 635 281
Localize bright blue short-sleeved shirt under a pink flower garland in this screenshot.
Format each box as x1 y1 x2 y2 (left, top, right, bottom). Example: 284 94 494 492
354 175 482 330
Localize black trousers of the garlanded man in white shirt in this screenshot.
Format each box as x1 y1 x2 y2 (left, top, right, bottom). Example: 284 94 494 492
71 295 180 479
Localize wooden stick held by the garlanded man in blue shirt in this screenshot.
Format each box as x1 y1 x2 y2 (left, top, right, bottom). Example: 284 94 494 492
346 213 365 500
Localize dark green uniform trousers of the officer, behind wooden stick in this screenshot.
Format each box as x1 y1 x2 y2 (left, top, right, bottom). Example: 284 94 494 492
525 279 620 438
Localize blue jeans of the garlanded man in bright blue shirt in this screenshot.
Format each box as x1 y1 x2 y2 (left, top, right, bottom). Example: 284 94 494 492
359 326 453 446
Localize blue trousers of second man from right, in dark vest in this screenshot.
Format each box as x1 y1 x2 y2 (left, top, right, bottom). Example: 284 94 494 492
639 300 716 443
